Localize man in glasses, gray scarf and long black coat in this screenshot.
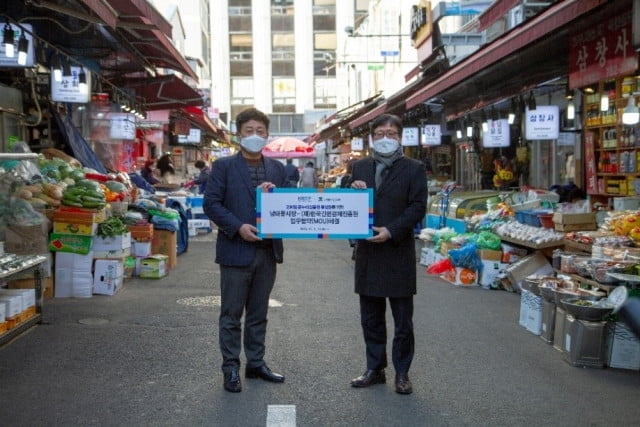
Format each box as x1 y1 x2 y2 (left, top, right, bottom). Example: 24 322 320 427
351 114 427 394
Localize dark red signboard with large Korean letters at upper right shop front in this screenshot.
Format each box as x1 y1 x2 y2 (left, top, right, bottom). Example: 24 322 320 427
569 10 638 89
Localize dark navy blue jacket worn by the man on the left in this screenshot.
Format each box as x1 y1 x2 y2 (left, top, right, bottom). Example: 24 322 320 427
203 153 287 267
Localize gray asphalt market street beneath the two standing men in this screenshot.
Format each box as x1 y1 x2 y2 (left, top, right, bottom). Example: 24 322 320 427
0 235 640 426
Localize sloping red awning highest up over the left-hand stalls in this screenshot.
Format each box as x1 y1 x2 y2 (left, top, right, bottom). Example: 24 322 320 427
83 0 198 81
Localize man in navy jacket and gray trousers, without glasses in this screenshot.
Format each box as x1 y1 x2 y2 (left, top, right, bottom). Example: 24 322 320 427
203 108 288 393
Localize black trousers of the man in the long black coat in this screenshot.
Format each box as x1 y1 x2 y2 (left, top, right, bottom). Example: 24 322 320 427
360 295 415 373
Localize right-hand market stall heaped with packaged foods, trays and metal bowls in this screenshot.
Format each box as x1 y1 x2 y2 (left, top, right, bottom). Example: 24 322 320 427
420 187 640 370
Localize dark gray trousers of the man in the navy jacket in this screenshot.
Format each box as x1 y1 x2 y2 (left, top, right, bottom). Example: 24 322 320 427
219 248 276 372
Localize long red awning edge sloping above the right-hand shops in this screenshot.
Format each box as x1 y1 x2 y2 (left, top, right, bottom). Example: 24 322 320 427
406 0 602 109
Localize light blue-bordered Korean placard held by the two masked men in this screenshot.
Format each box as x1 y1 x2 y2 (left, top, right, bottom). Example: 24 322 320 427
256 188 374 239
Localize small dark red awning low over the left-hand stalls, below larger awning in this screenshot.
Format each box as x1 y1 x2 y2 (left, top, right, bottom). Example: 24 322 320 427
125 74 204 110
